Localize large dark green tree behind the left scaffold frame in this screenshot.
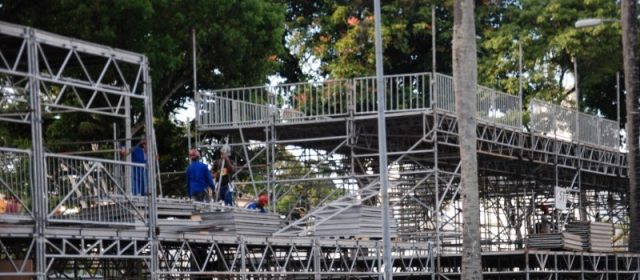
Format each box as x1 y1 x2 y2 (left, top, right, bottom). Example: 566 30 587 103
0 0 285 195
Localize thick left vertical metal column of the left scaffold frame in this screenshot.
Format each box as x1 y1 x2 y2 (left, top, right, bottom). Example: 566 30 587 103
25 28 47 280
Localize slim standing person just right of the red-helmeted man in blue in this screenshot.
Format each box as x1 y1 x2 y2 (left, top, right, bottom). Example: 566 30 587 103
213 145 236 206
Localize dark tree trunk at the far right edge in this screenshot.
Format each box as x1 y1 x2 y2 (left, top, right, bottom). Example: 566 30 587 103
622 0 640 253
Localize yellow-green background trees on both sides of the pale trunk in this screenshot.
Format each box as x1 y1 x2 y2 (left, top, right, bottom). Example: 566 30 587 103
282 0 624 119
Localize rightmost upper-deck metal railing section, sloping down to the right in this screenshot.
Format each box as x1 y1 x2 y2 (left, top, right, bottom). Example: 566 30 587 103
529 99 620 150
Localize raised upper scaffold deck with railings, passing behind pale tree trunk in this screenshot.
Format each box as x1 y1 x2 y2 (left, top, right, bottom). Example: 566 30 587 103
196 73 626 179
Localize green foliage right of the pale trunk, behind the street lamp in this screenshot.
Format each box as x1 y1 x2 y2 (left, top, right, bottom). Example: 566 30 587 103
478 0 622 118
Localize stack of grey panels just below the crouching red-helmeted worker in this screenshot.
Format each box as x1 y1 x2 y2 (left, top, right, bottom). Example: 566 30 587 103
194 208 284 236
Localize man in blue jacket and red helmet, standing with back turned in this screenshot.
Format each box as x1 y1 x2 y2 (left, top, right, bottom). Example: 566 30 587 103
187 149 215 202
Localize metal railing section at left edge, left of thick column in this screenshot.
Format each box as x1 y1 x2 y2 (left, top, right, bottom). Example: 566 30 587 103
0 148 33 217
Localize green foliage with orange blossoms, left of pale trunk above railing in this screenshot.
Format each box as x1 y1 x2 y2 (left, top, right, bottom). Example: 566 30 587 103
283 0 452 78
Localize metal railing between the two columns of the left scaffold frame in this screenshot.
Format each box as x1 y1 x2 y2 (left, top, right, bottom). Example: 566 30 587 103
45 154 146 225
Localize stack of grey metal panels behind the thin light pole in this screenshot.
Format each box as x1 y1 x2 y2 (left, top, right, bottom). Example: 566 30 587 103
314 205 398 239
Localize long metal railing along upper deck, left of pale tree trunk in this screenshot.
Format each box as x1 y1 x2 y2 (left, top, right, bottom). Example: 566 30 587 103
197 73 431 128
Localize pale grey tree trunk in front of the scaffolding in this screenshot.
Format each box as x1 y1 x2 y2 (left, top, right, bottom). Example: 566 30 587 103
453 0 482 280
